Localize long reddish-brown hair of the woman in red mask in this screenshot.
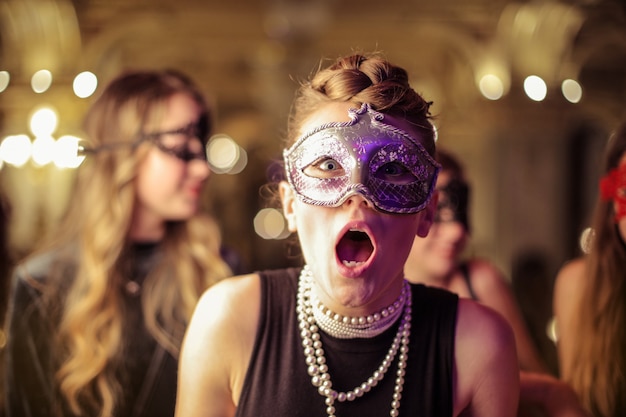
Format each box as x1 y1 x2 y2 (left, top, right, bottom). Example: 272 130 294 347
561 125 626 417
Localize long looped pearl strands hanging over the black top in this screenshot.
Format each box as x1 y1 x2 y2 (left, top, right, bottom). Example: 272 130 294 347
296 266 411 417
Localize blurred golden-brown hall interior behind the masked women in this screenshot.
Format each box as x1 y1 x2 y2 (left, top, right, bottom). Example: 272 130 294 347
0 0 626 316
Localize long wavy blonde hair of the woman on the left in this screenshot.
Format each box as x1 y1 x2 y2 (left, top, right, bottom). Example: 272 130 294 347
39 71 231 417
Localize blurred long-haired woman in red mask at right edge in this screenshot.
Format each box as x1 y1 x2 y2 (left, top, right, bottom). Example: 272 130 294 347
553 123 626 417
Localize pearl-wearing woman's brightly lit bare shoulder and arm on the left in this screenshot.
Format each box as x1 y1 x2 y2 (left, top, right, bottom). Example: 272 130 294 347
176 274 260 416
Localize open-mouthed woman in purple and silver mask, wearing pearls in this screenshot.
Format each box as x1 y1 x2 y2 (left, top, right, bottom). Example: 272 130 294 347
176 54 519 417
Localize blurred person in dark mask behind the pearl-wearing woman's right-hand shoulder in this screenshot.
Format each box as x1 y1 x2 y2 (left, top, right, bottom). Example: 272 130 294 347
405 147 587 417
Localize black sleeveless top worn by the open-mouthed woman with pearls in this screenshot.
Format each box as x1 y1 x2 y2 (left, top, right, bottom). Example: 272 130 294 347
235 268 458 417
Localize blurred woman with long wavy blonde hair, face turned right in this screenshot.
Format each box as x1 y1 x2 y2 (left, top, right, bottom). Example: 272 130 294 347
6 71 231 417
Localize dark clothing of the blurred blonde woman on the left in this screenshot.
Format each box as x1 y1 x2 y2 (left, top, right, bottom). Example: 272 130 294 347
5 244 178 417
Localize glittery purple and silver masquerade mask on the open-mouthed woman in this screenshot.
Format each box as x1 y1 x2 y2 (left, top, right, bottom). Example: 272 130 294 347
283 103 440 213
